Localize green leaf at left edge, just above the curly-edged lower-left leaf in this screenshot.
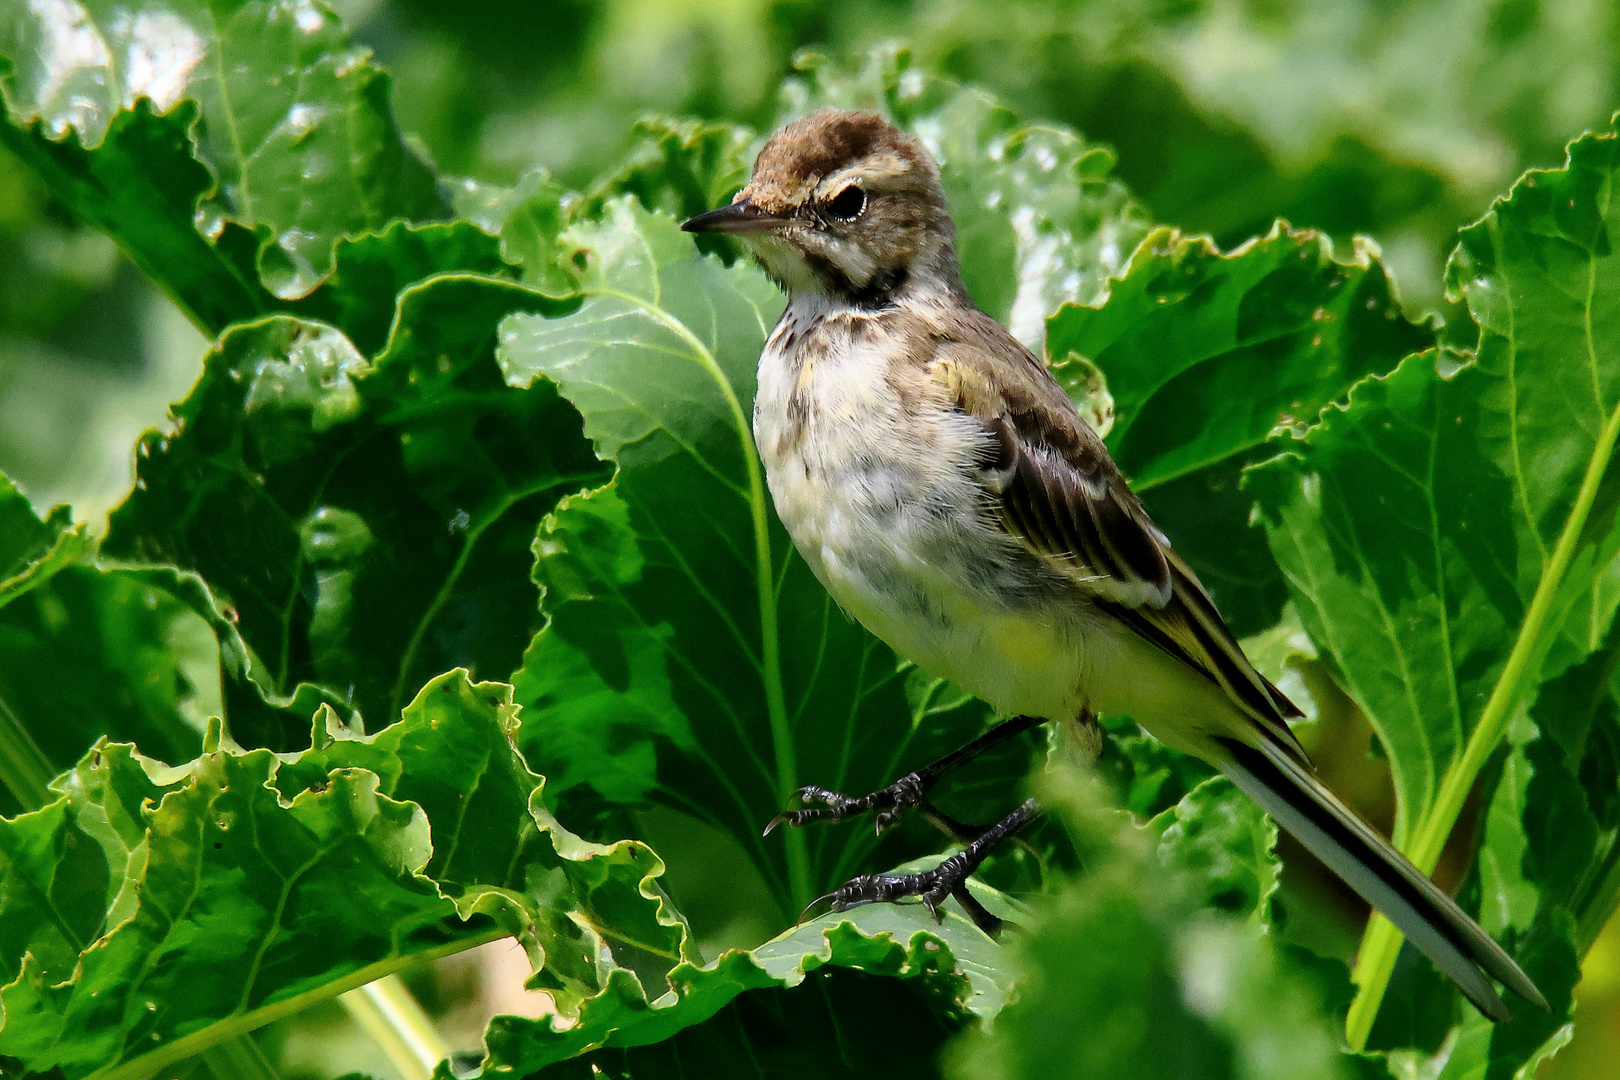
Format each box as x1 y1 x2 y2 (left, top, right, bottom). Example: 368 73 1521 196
0 478 348 813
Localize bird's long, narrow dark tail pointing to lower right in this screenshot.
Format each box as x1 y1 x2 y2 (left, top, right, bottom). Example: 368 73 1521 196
1220 738 1547 1023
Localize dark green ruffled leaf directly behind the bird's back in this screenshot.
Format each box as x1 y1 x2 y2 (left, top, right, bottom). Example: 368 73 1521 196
1047 227 1434 635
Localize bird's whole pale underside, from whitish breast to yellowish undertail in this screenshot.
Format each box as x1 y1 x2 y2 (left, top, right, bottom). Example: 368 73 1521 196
755 304 1233 753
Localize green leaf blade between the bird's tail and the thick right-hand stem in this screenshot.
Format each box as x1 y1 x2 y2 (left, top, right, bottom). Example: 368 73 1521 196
1246 353 1521 867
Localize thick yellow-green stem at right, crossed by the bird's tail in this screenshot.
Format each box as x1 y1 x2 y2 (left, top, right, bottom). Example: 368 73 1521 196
1345 395 1620 1051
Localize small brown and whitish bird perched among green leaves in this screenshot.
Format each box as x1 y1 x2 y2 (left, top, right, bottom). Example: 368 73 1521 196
682 108 1547 1022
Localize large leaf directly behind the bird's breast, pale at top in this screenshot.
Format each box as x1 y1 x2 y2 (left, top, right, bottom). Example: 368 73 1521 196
501 199 1022 916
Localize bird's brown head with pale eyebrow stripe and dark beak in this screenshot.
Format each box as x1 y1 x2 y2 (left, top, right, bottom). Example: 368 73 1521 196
682 108 956 306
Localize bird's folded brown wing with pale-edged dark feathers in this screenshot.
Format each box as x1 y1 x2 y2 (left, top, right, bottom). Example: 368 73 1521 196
935 310 1306 763
